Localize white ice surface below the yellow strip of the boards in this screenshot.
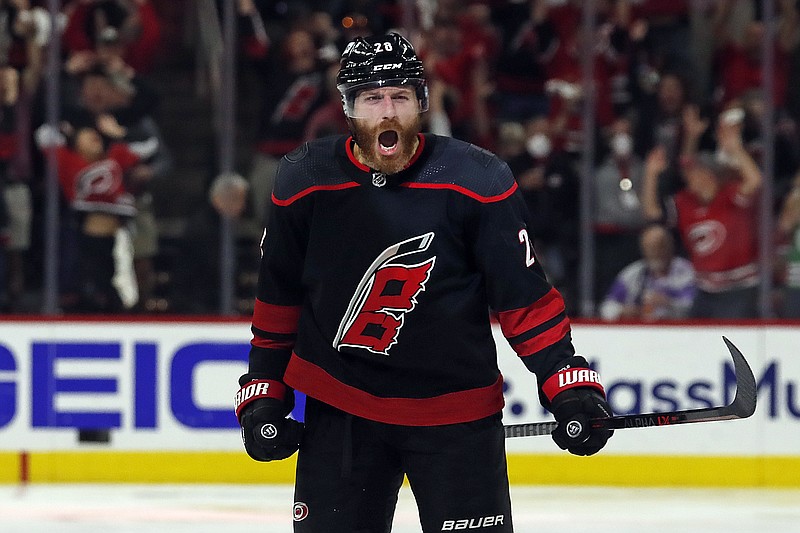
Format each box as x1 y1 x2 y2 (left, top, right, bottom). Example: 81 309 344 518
0 484 800 533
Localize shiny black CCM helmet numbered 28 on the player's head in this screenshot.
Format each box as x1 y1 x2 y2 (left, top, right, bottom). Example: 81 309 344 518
336 33 428 117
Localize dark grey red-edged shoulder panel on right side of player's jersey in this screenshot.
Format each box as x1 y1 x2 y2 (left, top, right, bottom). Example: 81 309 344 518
419 137 516 201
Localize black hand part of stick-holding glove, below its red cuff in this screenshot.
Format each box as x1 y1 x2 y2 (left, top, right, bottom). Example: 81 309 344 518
552 388 614 455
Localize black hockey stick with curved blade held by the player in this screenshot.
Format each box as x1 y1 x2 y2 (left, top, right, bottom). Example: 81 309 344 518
505 337 757 438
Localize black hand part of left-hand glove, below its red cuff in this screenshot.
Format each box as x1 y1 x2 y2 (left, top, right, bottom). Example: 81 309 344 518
239 398 303 461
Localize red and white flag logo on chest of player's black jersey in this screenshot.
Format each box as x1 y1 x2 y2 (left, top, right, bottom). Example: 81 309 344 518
333 233 436 355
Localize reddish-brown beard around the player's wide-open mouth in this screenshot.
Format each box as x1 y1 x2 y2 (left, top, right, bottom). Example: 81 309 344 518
350 115 422 174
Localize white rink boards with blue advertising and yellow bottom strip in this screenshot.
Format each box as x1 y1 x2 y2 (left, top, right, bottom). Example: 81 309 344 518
0 319 800 487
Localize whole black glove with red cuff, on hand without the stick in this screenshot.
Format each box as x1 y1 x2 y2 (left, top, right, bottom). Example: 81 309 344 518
235 380 303 461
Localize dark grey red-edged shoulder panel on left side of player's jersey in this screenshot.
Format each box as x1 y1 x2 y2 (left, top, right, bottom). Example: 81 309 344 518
272 136 351 204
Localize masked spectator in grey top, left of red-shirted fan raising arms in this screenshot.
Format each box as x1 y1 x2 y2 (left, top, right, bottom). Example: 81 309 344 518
592 118 645 302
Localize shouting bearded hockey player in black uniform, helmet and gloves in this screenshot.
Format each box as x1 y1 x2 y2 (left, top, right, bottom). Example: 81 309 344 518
235 33 611 533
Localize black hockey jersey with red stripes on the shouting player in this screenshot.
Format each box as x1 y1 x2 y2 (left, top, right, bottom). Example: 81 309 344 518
248 134 574 426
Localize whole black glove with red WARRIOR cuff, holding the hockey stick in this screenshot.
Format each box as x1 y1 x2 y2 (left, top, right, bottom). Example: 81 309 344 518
542 356 614 455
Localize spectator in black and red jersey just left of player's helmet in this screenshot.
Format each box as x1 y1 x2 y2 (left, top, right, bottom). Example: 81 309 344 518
248 29 328 221
